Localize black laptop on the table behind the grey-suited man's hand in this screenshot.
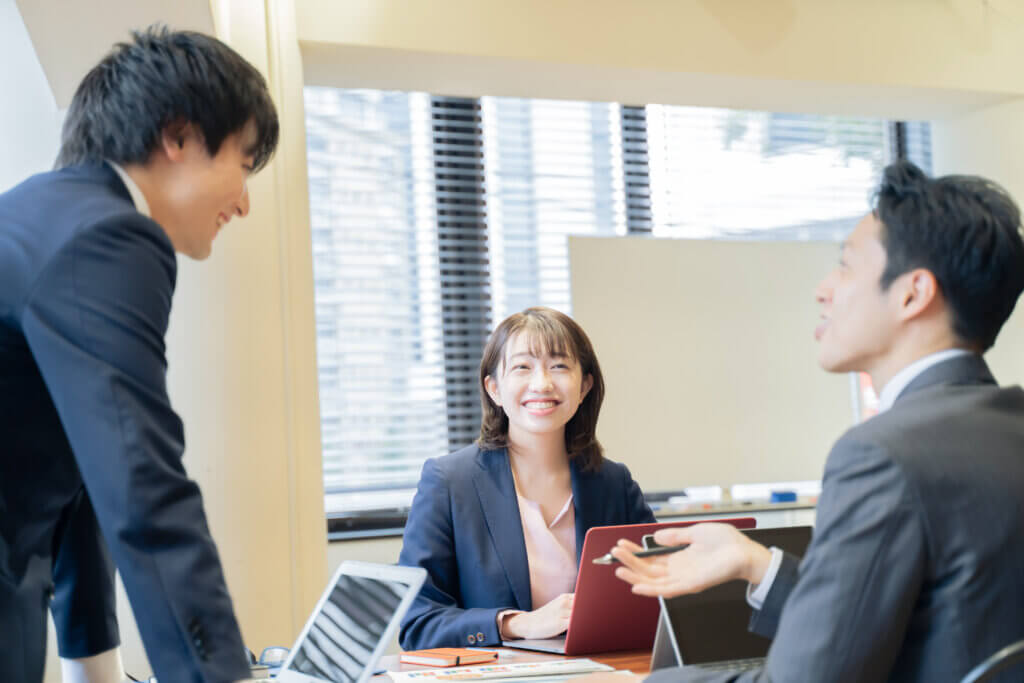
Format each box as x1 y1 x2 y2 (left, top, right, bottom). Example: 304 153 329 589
644 526 811 672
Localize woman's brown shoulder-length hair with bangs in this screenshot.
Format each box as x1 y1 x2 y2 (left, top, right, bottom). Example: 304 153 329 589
476 306 604 472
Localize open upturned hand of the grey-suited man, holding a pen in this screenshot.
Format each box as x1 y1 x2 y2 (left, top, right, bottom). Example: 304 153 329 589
611 523 771 598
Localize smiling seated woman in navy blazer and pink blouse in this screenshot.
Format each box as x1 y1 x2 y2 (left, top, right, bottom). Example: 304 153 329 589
398 308 654 649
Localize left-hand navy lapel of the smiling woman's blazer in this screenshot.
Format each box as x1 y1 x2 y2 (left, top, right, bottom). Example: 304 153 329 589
473 449 534 611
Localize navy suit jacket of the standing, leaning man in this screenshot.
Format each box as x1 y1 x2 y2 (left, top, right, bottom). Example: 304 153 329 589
0 164 249 683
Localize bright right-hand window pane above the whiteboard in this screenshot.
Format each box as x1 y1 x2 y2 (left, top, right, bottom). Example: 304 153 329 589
647 105 889 240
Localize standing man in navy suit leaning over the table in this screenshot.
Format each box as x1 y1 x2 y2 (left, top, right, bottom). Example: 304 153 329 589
0 29 278 683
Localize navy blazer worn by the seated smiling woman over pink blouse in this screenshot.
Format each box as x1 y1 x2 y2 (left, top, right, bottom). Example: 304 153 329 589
398 445 654 649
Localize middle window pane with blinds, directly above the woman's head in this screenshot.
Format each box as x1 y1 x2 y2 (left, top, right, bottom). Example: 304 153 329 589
474 97 626 319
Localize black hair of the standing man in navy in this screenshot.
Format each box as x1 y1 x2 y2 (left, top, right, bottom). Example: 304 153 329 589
56 26 278 170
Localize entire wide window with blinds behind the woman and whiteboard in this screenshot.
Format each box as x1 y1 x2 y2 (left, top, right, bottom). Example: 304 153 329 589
305 87 931 526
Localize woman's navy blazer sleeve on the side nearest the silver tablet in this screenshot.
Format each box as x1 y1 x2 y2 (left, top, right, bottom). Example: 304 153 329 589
398 460 505 650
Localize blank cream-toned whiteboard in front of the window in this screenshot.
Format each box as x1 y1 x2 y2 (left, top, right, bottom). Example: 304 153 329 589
569 237 854 492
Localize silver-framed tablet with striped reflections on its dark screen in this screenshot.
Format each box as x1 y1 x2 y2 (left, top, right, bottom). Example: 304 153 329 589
275 561 427 683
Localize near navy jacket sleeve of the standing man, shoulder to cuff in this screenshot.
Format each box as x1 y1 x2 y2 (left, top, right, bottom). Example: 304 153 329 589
22 218 249 681
